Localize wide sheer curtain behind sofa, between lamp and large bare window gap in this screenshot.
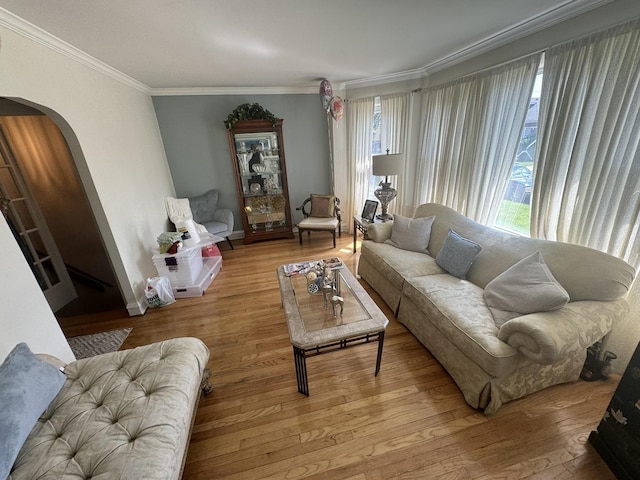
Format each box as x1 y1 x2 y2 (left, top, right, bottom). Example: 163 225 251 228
414 54 542 224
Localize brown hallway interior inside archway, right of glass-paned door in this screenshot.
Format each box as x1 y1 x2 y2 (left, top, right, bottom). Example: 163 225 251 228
0 99 124 317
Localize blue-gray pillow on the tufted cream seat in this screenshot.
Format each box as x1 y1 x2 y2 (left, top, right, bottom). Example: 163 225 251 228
0 343 65 478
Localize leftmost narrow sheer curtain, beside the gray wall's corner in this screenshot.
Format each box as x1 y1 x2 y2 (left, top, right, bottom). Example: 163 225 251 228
344 97 375 218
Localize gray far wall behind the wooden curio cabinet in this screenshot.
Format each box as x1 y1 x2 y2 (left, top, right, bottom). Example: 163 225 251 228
153 94 330 231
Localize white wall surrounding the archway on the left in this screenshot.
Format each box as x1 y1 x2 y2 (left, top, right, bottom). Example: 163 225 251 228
0 24 175 358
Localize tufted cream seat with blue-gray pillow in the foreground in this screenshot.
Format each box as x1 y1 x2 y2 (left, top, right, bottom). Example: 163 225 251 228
0 338 209 480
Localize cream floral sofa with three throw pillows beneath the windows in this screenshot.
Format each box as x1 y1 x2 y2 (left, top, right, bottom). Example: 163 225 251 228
358 204 635 414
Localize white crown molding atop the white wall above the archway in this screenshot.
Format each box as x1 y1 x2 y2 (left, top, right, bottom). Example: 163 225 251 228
0 7 150 94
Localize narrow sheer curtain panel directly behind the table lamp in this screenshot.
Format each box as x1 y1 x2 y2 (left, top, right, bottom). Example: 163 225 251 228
380 92 411 213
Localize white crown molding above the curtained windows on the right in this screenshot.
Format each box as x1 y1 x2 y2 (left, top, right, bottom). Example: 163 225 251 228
346 0 614 88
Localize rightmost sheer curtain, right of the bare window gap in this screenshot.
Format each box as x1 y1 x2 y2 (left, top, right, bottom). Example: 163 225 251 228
531 20 640 269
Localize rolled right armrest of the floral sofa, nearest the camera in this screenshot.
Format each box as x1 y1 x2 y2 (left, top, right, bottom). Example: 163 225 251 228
498 299 629 365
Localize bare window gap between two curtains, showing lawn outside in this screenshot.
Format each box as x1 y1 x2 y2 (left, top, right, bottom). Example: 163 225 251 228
495 68 542 236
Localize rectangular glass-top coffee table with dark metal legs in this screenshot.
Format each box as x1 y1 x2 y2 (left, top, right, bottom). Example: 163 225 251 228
277 262 389 396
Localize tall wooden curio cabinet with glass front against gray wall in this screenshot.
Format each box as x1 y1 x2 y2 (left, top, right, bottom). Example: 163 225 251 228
227 119 293 244
